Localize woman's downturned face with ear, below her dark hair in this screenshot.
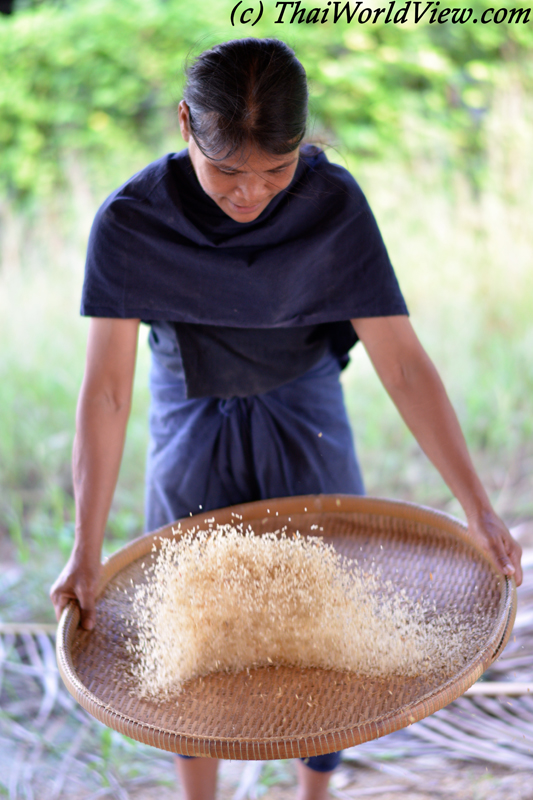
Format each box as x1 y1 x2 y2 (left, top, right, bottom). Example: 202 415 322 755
179 101 299 222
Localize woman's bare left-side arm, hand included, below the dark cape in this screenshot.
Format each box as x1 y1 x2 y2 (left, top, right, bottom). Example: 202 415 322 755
50 319 139 629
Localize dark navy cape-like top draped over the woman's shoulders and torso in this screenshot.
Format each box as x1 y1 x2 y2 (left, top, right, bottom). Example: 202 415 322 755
81 147 407 397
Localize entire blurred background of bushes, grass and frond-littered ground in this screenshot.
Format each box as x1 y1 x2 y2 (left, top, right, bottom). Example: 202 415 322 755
0 0 533 800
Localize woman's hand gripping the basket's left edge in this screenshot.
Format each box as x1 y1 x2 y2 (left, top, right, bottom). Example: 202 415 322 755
50 551 101 631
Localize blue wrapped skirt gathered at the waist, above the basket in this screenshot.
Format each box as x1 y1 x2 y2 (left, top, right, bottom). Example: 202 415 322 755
146 354 364 531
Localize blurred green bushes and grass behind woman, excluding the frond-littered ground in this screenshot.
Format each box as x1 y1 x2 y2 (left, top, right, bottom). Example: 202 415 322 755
0 0 533 622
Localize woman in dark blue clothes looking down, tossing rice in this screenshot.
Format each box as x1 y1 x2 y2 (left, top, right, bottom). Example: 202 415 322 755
51 39 521 800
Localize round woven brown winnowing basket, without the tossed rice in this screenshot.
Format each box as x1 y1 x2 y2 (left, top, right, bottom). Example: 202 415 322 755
57 495 516 760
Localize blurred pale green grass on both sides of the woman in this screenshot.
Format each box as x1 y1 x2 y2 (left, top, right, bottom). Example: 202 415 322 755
0 97 533 621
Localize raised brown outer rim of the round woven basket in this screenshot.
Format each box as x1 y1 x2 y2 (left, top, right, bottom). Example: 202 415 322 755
56 494 516 759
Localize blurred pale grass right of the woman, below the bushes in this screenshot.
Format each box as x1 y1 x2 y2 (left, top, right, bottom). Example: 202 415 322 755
345 95 533 524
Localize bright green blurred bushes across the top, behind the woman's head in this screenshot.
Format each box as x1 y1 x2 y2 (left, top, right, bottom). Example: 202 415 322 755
0 0 533 199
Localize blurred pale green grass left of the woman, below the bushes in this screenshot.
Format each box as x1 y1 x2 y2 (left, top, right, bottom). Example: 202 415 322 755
0 241 149 621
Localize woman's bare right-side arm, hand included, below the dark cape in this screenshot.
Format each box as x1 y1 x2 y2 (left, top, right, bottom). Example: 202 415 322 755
352 316 522 585
